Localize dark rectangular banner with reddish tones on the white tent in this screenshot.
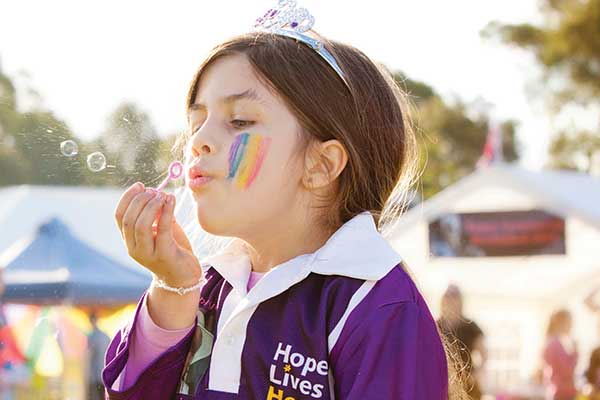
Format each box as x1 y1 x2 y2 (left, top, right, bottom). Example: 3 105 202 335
429 210 565 257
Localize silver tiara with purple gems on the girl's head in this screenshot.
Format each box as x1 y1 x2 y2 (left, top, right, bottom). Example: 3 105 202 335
254 0 348 86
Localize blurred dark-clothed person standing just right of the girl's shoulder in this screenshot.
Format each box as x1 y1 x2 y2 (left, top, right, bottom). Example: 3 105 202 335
438 284 487 400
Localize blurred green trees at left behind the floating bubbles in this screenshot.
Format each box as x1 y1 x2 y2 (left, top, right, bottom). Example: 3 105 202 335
0 63 183 186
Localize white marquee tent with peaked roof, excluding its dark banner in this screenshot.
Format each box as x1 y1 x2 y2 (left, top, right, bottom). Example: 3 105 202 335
388 164 600 396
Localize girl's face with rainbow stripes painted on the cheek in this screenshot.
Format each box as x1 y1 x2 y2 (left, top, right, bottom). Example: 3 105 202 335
186 55 306 240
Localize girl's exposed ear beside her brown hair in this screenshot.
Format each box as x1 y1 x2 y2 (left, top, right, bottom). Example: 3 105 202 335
302 139 348 189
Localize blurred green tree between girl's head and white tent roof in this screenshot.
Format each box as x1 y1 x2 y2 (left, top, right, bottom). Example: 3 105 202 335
394 72 518 198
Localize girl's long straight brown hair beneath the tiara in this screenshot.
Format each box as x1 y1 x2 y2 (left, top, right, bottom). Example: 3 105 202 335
178 32 467 400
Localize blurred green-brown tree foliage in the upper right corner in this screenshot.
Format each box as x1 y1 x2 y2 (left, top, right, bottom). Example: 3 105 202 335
483 0 600 172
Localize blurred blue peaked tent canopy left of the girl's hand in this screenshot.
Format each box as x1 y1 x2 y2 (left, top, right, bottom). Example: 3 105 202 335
0 218 151 306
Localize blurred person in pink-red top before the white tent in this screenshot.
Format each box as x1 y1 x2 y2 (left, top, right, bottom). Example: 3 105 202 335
543 309 578 400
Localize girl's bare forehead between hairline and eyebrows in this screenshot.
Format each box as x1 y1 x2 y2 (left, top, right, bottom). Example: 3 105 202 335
193 54 277 106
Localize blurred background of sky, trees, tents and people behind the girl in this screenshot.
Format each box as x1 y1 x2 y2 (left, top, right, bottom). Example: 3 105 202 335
0 0 600 399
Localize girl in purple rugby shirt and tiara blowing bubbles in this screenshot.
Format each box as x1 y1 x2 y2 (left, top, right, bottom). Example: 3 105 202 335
103 1 459 400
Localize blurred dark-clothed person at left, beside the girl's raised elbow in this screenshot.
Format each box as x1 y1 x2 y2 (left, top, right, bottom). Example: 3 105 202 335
88 312 110 400
